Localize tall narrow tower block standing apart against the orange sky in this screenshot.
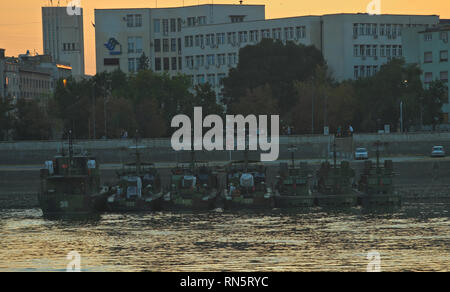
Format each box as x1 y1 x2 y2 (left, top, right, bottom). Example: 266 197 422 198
42 7 85 77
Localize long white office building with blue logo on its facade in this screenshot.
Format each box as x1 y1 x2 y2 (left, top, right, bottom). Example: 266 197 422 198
95 4 439 93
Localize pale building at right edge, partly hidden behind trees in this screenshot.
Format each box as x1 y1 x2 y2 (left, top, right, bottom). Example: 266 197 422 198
403 23 450 123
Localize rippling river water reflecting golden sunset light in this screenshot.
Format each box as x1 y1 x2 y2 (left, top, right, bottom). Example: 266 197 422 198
0 202 450 272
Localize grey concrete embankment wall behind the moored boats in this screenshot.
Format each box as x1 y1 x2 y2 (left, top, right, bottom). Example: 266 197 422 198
0 132 450 165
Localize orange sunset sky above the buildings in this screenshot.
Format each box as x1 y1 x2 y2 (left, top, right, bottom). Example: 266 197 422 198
0 0 450 75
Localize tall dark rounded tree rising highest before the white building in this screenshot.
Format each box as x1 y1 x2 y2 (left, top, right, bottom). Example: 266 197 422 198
224 39 325 118
